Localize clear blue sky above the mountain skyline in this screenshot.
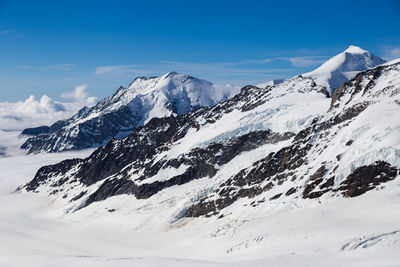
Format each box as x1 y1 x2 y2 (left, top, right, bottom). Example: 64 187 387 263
0 0 400 101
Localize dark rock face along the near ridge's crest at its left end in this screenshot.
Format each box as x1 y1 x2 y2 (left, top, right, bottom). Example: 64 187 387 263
22 117 182 191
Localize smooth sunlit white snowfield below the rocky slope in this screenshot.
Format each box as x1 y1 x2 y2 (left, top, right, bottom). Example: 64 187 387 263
0 146 400 266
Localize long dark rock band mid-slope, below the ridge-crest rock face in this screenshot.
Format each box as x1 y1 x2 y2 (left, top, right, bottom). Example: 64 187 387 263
80 131 293 209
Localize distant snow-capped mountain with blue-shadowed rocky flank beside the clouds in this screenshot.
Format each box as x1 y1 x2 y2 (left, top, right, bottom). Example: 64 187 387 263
21 72 235 153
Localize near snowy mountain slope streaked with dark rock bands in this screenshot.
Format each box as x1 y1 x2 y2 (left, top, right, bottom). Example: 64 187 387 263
19 61 400 223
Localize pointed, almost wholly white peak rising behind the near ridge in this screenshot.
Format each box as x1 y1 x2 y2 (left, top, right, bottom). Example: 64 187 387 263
303 45 386 95
